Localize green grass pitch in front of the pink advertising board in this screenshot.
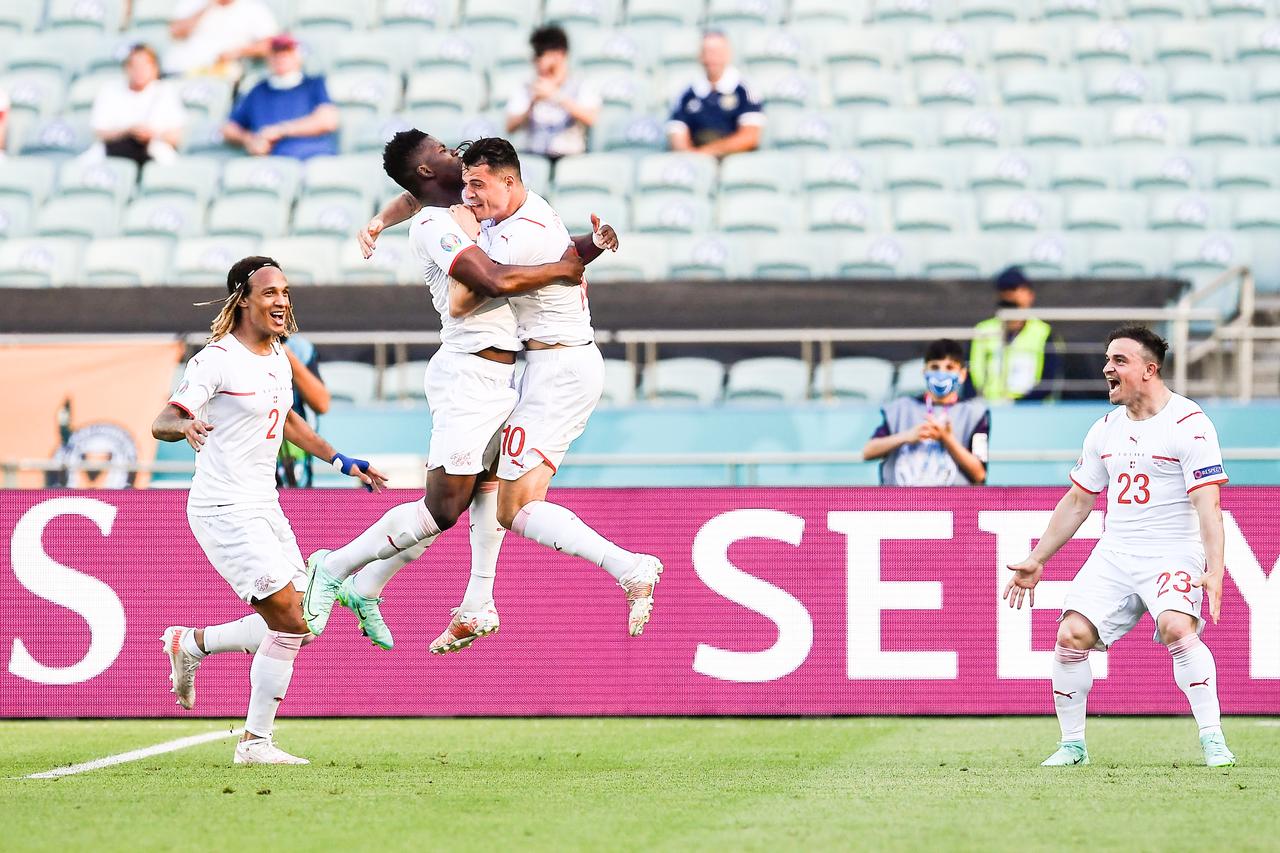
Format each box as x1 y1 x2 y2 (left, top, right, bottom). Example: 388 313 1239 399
0 717 1280 853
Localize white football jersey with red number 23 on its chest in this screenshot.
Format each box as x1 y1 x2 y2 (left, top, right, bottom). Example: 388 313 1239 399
1070 394 1228 555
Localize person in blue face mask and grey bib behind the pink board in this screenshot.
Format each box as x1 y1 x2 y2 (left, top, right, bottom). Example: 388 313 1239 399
863 338 991 485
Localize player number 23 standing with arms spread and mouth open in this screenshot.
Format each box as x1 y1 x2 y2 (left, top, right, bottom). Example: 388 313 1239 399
1004 325 1235 767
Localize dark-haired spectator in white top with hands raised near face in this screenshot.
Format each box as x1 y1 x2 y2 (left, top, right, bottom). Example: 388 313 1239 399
507 24 600 160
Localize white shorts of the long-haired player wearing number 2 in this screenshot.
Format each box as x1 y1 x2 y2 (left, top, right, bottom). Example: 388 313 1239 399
187 503 307 603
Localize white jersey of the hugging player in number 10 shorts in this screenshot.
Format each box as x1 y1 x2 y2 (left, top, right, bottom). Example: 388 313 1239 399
477 192 595 346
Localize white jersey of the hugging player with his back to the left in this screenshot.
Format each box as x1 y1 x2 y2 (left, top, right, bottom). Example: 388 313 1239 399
408 207 519 352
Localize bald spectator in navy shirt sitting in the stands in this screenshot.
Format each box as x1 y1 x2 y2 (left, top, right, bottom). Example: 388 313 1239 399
667 32 764 158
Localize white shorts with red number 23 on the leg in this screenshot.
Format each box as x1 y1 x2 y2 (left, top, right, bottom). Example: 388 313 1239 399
1062 548 1204 648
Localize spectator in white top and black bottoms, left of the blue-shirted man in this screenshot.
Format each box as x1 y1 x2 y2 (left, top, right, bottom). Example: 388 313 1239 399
87 45 186 165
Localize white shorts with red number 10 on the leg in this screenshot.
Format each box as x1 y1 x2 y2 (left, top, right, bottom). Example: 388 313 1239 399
498 343 604 480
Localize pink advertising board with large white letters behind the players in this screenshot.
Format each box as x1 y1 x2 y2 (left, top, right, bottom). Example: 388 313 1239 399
0 487 1280 717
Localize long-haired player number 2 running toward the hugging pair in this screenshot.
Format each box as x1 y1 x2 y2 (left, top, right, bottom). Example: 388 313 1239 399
151 256 387 765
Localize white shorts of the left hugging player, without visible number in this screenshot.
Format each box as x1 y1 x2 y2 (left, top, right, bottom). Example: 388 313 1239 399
425 350 516 474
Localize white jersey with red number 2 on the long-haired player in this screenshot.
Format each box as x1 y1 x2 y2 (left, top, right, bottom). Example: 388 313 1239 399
169 334 293 515
